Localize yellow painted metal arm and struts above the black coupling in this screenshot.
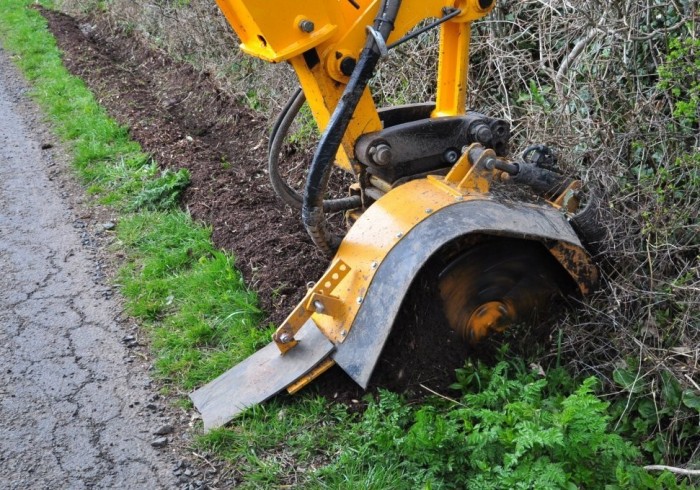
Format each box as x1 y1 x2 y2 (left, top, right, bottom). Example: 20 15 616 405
216 0 495 173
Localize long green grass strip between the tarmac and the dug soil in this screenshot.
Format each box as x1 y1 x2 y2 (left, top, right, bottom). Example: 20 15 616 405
0 0 262 390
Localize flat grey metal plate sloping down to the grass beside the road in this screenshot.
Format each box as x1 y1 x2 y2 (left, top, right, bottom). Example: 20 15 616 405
190 318 334 431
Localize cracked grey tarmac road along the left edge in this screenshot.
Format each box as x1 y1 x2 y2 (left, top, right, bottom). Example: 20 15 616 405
0 48 177 489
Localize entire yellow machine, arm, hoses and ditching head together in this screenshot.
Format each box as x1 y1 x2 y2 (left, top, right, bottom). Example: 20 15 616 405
191 0 598 429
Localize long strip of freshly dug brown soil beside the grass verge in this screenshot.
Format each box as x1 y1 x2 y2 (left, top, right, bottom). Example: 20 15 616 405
42 6 328 323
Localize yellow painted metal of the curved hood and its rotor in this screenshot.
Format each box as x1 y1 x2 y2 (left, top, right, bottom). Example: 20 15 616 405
276 145 598 391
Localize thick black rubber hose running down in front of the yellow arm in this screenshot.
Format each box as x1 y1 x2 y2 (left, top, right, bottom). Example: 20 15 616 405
301 0 401 255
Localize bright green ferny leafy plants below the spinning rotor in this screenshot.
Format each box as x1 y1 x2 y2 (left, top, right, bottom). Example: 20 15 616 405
317 361 688 489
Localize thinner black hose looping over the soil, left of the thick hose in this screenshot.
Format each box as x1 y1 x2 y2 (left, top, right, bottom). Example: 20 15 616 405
267 88 362 213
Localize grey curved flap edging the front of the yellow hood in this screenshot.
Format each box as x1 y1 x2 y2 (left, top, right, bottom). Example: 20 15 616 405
332 200 587 389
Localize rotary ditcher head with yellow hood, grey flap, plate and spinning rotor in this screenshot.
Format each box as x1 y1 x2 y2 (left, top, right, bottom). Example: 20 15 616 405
191 174 597 429
